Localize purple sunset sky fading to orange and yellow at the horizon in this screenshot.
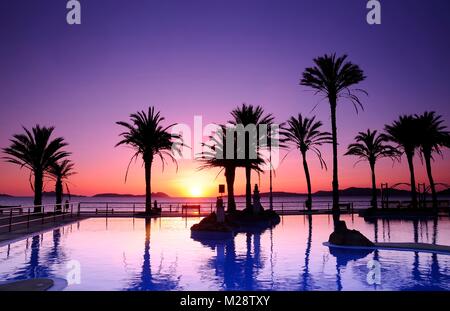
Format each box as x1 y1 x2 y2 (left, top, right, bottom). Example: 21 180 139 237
0 0 450 195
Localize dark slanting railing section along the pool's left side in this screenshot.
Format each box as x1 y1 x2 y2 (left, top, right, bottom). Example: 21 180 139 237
0 203 80 232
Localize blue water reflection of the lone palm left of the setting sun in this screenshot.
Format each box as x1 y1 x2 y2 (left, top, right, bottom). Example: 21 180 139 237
128 218 179 291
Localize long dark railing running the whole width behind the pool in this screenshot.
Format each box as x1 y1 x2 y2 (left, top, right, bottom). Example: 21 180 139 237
12 199 449 232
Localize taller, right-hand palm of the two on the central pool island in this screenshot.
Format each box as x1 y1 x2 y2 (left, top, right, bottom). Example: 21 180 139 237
231 103 274 208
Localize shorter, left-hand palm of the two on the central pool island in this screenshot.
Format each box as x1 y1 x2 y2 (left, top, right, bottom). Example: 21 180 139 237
197 125 264 212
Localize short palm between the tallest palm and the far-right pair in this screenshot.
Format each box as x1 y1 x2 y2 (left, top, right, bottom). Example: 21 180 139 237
345 129 400 208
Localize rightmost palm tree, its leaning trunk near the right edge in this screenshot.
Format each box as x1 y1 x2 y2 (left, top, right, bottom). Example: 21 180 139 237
415 111 450 209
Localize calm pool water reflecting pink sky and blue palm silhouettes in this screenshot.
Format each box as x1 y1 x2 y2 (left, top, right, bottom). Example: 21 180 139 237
0 215 450 291
